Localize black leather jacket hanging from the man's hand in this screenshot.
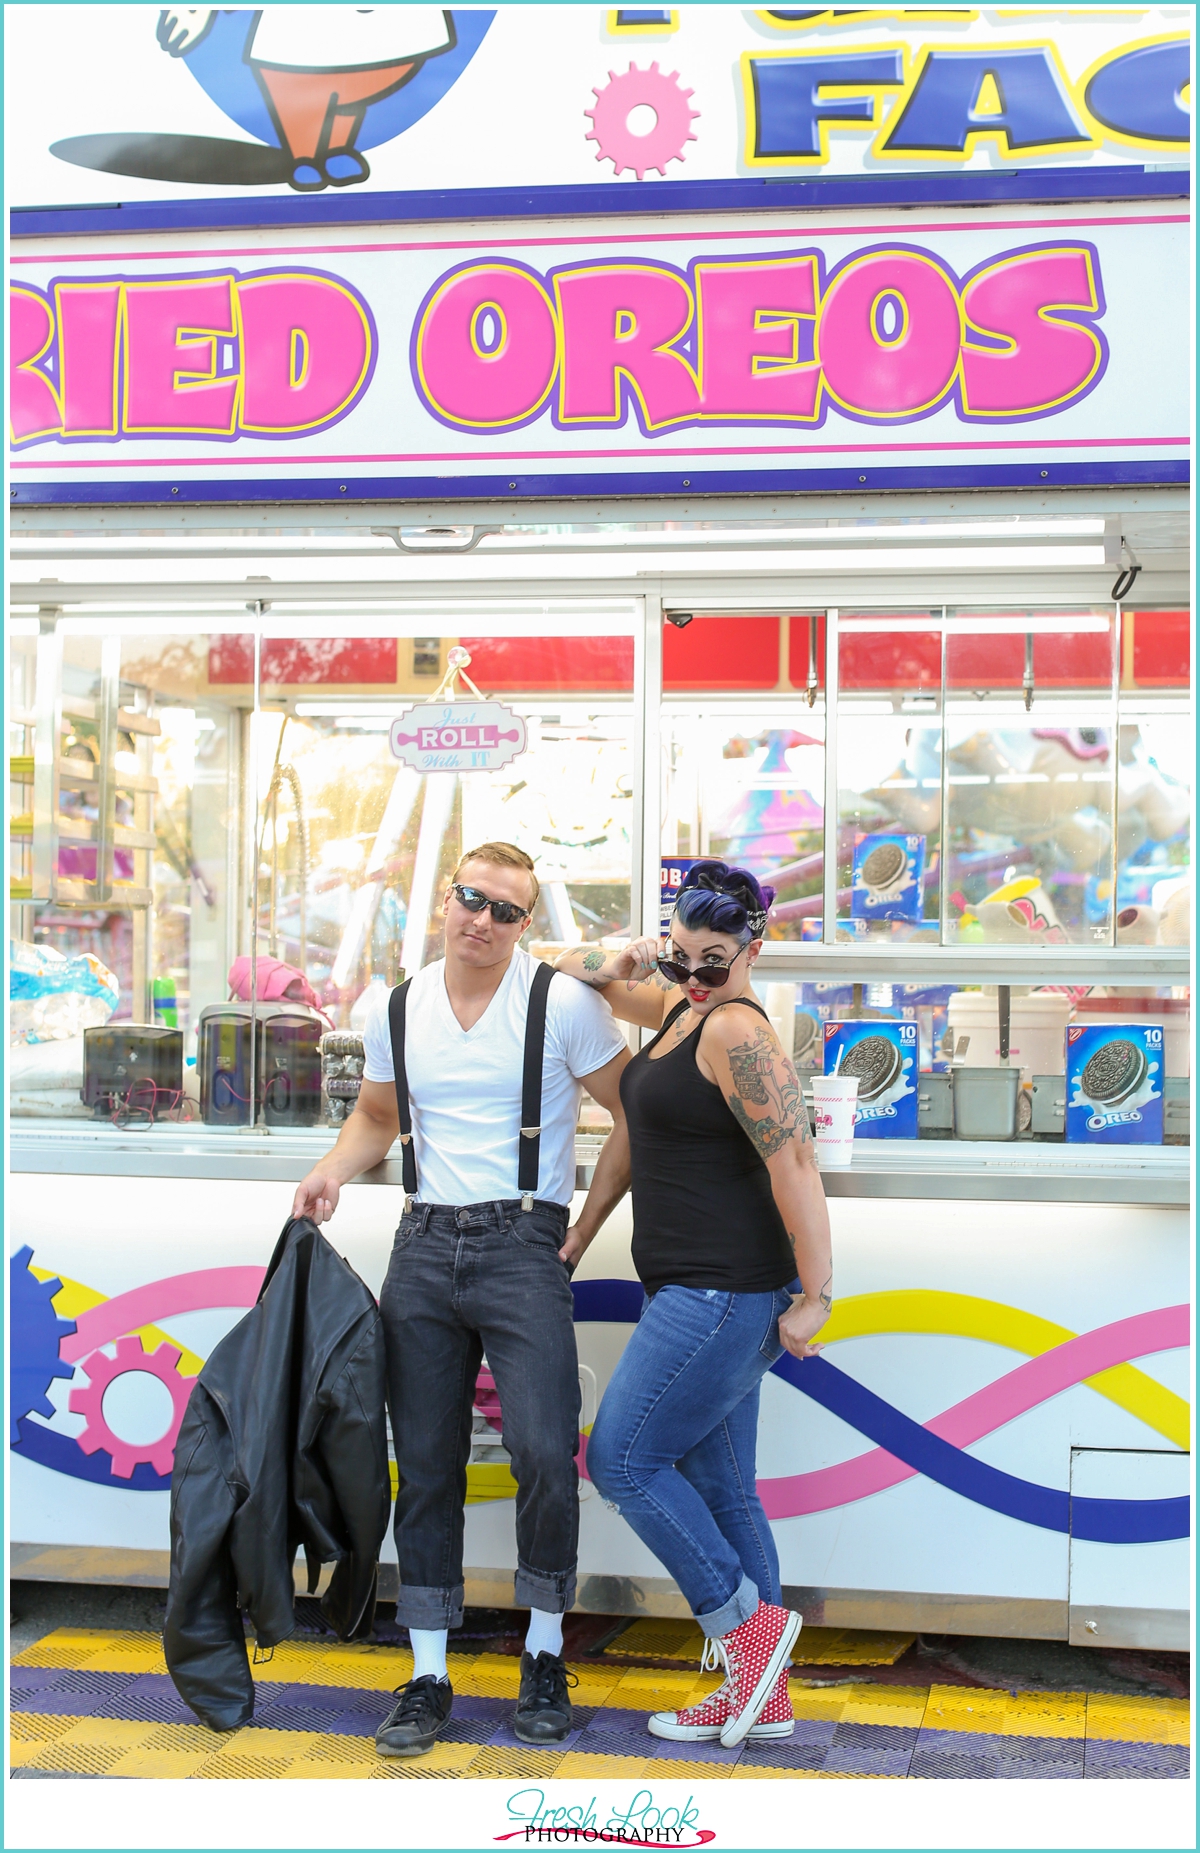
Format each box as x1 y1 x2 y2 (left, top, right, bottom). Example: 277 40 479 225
163 1217 391 1731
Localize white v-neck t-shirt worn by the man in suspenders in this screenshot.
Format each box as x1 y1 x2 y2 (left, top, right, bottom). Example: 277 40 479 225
363 947 626 1206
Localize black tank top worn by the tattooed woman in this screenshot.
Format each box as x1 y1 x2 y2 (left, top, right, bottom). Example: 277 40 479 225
620 997 796 1293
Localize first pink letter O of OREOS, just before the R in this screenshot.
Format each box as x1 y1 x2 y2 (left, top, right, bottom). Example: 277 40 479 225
413 263 557 430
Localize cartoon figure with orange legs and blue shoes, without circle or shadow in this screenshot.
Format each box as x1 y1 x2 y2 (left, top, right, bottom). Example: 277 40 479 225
157 6 456 193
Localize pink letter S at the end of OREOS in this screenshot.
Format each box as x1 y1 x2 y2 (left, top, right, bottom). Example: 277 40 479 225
963 248 1104 417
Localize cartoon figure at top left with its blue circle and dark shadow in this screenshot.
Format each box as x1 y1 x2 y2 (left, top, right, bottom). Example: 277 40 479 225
50 6 496 193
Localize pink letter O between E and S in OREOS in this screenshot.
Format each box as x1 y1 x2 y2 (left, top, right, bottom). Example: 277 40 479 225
817 250 963 419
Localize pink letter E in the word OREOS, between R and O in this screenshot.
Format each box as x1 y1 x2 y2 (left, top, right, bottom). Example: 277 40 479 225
696 258 820 419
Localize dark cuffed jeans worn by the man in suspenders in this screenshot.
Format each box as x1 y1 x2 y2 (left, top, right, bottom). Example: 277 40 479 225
380 1197 580 1629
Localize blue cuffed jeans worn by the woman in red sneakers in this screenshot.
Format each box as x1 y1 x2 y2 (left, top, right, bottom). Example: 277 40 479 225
587 1286 791 1636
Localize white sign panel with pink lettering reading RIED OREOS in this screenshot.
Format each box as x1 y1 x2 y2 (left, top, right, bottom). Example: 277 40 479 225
9 202 1191 496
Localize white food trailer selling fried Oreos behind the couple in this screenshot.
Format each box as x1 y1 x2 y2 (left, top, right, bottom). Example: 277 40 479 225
7 7 1193 1647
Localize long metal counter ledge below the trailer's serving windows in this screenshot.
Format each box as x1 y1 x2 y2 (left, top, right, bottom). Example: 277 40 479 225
9 1119 1191 1208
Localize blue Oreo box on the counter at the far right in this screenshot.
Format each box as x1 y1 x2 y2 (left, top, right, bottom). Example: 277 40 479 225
1067 1023 1165 1145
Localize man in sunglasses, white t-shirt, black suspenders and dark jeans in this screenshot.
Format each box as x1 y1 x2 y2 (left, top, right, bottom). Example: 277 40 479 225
294 843 630 1757
